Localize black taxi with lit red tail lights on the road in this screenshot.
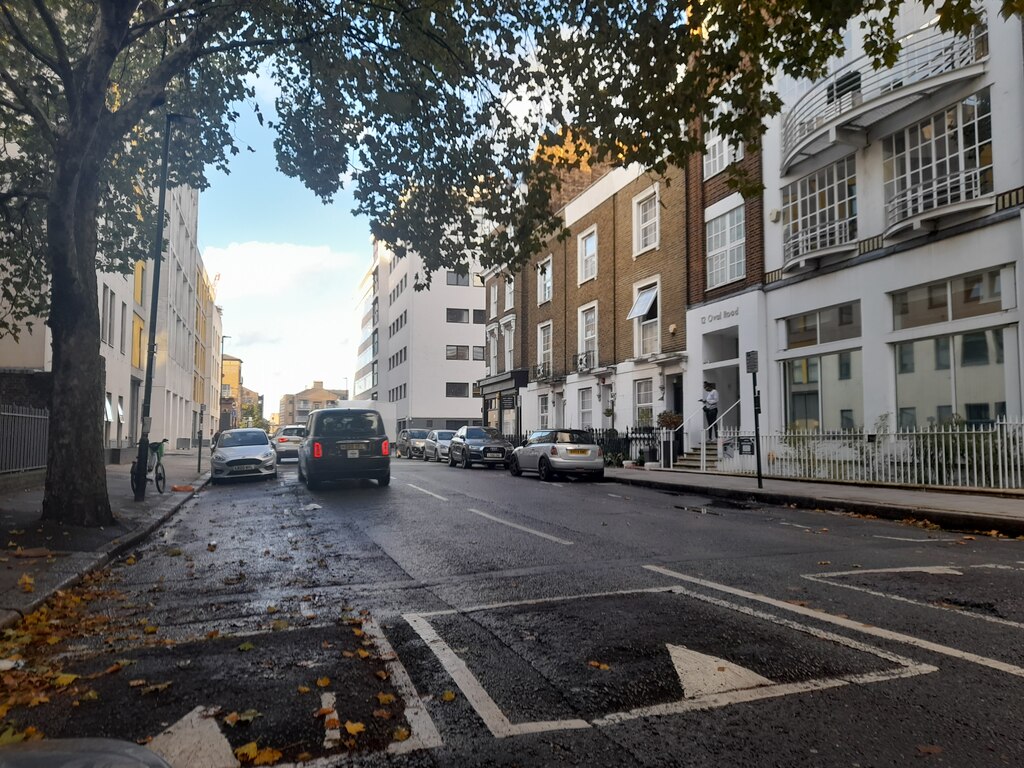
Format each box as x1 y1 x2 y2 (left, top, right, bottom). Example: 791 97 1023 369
299 408 391 490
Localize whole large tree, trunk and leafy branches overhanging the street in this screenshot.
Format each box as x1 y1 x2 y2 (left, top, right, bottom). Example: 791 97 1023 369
0 0 1024 519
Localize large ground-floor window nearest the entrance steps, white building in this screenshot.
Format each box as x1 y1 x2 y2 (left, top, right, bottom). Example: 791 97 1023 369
783 349 864 430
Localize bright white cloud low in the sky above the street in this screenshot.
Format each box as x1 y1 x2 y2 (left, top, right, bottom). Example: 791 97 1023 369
203 243 369 417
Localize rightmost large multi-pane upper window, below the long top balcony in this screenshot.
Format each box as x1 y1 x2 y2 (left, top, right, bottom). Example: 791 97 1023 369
882 89 992 226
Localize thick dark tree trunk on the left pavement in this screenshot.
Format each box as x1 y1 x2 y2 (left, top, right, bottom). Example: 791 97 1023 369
43 145 114 526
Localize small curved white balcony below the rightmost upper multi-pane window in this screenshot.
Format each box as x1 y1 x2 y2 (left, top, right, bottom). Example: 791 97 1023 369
886 166 992 238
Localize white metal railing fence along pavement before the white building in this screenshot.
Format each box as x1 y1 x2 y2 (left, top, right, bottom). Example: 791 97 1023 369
718 421 1024 488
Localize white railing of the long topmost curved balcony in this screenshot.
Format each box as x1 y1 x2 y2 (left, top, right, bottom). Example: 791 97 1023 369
782 16 988 167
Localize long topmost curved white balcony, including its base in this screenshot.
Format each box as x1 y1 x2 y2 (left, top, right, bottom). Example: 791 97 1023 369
782 23 988 173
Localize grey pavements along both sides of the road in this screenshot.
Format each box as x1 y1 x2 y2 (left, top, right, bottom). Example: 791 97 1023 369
0 451 1024 628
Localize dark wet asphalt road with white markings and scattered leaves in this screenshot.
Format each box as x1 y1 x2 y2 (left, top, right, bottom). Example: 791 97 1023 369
8 460 1024 768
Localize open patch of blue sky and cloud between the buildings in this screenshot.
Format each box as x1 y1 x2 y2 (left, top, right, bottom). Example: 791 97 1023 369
199 97 373 418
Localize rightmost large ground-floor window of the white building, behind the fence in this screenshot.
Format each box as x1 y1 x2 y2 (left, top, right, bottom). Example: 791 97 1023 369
896 328 1007 429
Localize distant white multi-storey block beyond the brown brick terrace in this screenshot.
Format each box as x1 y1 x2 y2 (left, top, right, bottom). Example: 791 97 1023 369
353 243 486 434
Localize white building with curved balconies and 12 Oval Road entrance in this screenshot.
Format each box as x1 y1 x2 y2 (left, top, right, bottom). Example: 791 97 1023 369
686 2 1024 442
